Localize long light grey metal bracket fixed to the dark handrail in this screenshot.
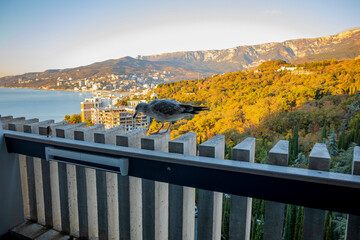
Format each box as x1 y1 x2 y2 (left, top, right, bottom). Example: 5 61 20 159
45 147 129 176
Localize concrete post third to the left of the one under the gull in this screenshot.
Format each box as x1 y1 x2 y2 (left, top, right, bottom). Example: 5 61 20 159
73 124 107 239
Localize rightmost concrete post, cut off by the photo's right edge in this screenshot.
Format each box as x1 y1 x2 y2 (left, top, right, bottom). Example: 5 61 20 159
345 146 360 240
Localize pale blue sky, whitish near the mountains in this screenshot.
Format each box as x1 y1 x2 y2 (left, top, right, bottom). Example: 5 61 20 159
0 0 360 77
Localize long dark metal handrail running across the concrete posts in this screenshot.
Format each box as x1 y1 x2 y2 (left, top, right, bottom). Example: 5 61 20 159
4 131 360 215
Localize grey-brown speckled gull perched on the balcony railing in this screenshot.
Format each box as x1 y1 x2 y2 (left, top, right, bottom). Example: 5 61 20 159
133 99 209 134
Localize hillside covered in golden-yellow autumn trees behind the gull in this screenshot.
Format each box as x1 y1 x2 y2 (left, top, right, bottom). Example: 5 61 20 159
151 58 360 148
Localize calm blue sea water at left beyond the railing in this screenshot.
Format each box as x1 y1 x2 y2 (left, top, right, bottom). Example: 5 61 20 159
0 88 93 122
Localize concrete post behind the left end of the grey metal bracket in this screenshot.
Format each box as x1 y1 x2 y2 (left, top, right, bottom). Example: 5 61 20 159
39 121 70 230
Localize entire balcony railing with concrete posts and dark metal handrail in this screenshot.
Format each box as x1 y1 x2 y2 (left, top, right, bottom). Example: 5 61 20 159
0 117 360 240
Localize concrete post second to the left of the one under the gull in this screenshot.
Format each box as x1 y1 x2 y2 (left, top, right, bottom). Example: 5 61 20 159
94 126 125 239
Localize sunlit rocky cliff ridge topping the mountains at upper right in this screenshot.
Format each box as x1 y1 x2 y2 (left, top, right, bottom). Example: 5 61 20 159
137 29 360 72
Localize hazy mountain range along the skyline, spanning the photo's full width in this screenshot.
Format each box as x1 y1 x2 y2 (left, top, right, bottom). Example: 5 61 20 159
0 29 360 86
